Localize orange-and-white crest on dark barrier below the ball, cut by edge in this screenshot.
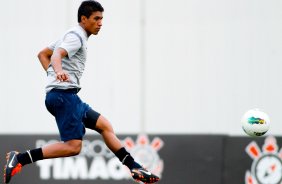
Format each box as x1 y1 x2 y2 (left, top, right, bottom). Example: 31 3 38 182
245 136 282 184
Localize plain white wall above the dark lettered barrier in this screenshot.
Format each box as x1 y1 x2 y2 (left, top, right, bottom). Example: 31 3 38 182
0 0 282 135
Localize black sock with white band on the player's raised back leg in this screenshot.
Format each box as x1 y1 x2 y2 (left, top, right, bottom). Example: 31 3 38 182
17 148 43 166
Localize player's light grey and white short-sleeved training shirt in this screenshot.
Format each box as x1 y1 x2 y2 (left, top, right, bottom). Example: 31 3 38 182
46 25 88 93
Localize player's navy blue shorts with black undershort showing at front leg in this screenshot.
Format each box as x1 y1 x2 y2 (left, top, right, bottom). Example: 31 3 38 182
45 89 100 141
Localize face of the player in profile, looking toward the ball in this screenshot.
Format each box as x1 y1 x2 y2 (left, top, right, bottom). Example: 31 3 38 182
82 11 103 36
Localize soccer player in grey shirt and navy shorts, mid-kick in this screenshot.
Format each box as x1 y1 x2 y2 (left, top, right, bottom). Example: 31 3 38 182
4 0 159 183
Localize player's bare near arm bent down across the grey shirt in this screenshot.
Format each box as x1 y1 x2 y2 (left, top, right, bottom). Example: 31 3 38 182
51 48 69 81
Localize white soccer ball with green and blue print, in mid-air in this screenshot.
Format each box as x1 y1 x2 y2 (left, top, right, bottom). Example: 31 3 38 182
241 109 270 137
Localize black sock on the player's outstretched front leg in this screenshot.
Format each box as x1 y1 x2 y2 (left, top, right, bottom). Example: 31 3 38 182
115 148 142 170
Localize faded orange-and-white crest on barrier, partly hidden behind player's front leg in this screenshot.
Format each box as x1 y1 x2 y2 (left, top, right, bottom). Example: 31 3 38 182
124 135 164 177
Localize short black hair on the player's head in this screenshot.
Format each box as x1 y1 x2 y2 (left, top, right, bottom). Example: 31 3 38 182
77 0 104 22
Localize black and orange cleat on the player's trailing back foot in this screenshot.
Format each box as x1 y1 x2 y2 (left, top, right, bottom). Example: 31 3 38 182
4 151 22 183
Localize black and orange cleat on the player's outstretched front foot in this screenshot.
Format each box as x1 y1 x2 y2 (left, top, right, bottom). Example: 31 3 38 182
131 168 160 183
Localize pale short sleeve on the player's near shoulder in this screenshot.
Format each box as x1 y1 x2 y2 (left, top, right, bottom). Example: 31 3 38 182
58 33 82 58
